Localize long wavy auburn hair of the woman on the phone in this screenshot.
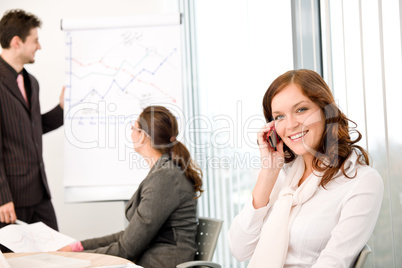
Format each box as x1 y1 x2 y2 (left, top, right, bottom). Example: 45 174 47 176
262 69 370 188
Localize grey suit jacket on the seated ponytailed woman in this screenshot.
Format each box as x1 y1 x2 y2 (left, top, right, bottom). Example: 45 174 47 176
81 154 197 268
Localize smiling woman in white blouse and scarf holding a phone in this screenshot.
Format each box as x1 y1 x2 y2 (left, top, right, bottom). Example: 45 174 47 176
229 70 384 268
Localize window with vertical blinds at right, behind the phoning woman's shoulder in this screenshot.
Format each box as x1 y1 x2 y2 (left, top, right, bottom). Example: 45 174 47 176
321 0 402 267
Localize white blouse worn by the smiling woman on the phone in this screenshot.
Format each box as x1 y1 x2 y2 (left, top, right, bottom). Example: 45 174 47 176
228 153 384 268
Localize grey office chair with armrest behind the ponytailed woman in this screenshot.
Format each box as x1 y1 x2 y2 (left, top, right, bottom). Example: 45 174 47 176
176 217 223 268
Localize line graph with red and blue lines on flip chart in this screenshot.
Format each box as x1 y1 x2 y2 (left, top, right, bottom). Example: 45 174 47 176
65 27 181 116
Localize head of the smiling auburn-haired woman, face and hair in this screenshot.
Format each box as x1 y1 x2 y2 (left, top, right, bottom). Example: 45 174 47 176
263 69 369 186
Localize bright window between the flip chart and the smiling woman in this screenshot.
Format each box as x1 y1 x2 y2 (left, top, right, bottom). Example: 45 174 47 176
183 0 293 267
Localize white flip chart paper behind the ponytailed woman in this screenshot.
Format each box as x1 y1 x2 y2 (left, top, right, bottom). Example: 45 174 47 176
64 14 183 199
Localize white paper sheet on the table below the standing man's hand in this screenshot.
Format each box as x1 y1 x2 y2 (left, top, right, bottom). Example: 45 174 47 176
0 222 76 253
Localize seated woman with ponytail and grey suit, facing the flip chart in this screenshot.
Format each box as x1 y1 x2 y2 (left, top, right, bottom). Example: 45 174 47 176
61 106 202 268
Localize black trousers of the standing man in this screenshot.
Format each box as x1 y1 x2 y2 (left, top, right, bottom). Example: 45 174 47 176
0 199 59 252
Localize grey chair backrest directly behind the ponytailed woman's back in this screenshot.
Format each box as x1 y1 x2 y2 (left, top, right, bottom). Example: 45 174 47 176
194 217 223 261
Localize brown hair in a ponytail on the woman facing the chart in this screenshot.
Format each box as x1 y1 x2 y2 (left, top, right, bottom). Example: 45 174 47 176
138 106 204 198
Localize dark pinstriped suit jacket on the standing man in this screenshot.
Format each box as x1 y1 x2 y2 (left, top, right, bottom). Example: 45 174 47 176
0 58 63 207
